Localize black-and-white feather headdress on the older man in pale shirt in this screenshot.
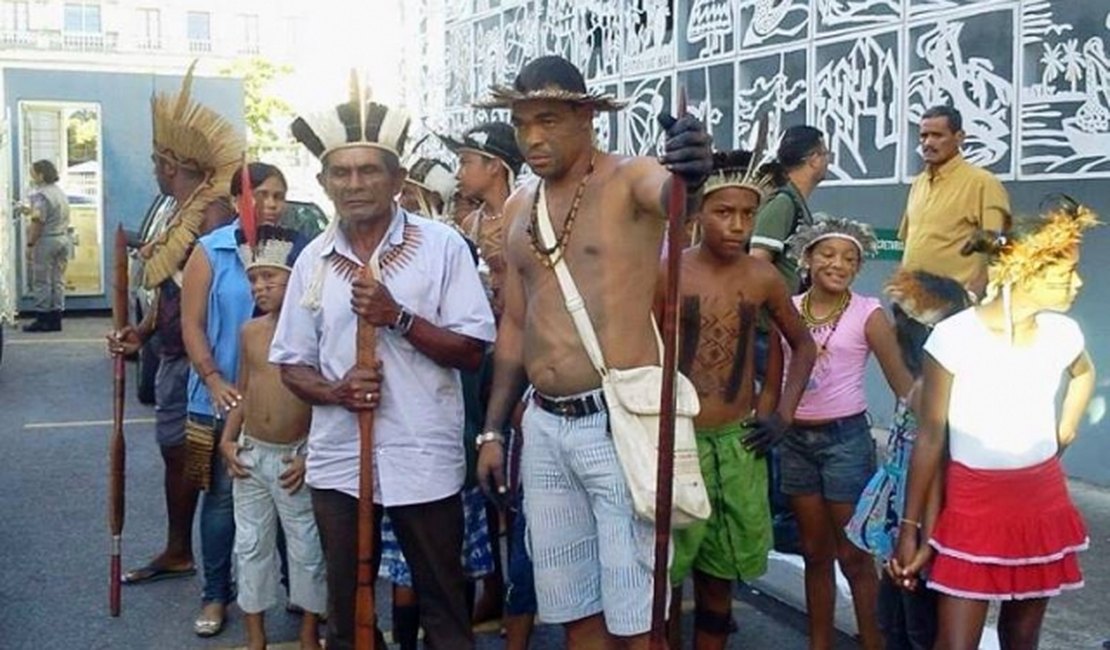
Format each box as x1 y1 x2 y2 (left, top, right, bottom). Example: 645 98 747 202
290 71 410 160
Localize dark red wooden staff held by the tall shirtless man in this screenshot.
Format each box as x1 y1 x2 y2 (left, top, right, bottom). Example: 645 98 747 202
650 88 686 650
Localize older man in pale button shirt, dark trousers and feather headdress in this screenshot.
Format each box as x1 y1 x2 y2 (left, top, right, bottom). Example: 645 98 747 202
270 74 494 650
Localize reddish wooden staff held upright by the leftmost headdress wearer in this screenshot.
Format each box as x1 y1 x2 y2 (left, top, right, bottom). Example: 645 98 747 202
108 225 129 617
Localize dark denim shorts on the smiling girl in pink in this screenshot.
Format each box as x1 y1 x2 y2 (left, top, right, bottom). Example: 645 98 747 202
779 413 876 504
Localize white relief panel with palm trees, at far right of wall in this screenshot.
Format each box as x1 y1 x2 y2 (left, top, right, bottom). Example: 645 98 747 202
1019 1 1110 179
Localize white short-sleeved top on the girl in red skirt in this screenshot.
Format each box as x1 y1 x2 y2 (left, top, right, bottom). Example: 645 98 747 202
925 308 1086 469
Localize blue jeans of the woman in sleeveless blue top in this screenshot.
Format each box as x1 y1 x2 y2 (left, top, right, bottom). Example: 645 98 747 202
189 413 235 605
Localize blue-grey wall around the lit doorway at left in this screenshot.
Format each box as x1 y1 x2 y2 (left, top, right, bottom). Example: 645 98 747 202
3 69 244 309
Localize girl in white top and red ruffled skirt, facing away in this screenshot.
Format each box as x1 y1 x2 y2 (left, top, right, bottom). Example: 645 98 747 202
890 198 1097 650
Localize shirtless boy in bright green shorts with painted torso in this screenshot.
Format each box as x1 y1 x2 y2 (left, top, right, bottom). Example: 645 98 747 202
656 151 816 650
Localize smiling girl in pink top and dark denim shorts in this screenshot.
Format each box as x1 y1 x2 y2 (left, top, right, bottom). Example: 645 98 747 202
780 216 914 650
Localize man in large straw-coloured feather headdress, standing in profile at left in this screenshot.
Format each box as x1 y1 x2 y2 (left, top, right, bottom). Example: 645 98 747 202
109 62 243 583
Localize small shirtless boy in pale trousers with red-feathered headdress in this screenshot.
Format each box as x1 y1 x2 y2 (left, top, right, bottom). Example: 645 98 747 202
220 226 327 650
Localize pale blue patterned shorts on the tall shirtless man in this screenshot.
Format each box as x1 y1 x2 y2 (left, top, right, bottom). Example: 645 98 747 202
521 392 655 637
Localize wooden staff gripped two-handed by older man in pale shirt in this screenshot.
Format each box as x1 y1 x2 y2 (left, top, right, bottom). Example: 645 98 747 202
354 260 377 650
